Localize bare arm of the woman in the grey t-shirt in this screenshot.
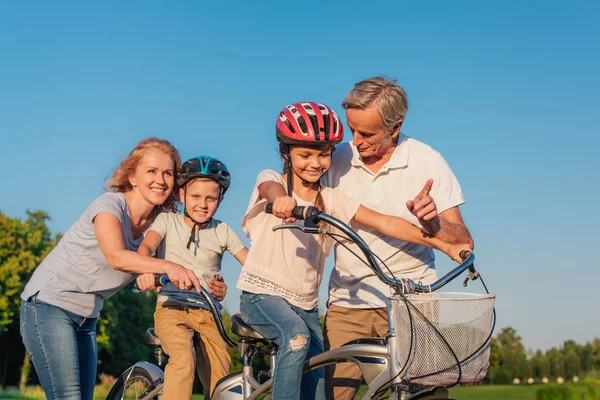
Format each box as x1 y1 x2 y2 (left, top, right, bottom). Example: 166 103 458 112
94 212 200 291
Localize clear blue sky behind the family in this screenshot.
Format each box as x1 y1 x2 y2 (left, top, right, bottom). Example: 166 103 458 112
0 1 600 349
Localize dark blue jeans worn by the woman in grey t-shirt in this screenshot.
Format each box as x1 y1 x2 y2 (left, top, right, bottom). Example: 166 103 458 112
21 294 98 400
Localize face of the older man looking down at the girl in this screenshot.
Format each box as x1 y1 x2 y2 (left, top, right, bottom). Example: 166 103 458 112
346 108 402 159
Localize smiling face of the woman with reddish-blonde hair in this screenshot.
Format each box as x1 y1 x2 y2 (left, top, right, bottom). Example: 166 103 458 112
129 149 175 206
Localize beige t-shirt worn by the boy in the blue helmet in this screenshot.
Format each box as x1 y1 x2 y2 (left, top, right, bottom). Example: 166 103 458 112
148 212 245 302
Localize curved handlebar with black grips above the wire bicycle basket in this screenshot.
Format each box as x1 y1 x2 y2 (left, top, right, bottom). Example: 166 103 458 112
265 203 479 293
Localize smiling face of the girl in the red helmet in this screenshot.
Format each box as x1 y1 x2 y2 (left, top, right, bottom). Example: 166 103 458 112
289 145 333 183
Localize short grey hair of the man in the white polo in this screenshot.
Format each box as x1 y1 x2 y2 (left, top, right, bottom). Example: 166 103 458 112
342 76 408 130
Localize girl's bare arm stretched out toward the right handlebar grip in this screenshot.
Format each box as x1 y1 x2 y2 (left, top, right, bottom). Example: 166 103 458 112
353 205 472 262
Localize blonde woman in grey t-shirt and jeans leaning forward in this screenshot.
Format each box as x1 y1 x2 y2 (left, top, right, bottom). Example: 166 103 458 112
21 138 200 400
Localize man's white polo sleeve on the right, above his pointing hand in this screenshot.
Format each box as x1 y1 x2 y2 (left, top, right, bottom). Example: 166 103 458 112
429 155 465 213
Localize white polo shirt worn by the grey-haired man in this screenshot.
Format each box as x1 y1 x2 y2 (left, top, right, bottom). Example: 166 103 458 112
323 134 464 308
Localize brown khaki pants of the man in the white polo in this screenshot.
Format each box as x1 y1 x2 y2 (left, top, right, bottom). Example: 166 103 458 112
323 305 388 400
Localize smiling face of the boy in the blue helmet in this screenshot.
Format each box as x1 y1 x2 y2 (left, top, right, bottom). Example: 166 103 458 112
179 178 222 223
